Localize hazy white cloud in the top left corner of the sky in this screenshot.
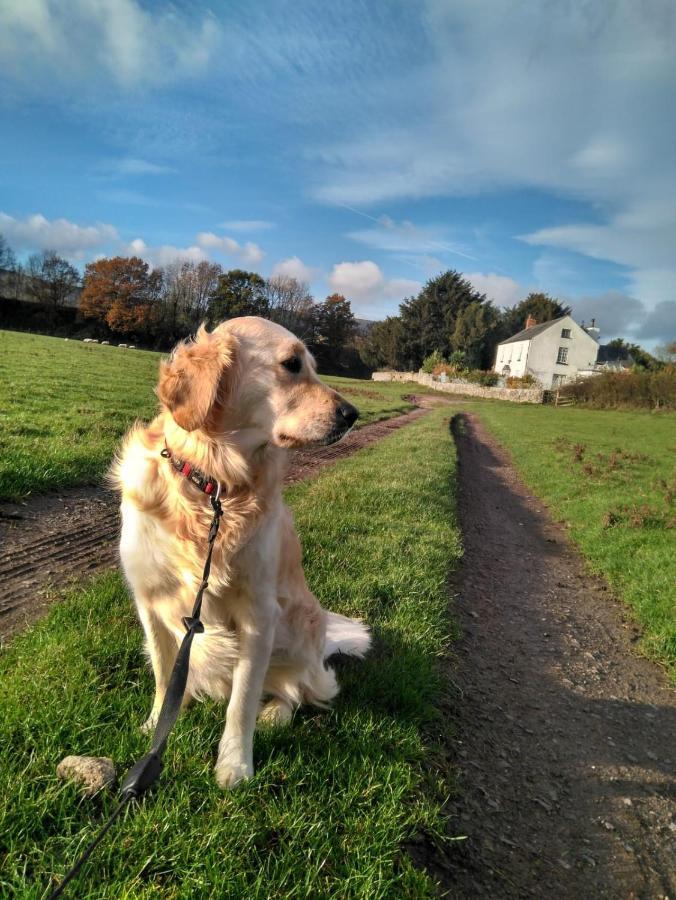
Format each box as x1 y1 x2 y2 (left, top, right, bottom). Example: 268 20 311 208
0 0 222 89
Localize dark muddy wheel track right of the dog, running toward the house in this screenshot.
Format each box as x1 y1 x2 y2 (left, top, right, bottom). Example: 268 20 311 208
430 415 676 900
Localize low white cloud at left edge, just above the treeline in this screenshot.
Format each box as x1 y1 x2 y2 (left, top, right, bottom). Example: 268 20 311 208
0 212 118 260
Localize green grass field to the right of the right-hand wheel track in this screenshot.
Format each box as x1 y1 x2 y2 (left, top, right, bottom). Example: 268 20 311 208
469 401 676 677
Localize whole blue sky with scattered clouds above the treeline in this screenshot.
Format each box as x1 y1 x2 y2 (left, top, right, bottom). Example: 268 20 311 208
0 0 676 346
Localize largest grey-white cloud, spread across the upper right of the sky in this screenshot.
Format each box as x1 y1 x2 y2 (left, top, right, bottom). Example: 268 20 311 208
315 0 676 304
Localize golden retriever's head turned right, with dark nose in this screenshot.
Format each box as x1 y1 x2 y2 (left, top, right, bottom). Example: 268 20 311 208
157 316 359 447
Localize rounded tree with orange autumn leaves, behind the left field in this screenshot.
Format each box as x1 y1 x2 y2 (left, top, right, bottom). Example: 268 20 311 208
80 256 162 334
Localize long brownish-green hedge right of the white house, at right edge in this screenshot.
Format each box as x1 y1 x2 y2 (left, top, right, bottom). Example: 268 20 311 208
560 365 676 409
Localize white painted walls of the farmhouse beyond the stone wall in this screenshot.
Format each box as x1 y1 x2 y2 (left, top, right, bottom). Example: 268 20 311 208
494 316 599 388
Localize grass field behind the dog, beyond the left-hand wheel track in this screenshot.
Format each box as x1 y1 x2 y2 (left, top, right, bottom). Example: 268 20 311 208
0 331 420 500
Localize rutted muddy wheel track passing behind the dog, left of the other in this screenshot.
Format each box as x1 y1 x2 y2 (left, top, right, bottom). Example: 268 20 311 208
0 404 425 641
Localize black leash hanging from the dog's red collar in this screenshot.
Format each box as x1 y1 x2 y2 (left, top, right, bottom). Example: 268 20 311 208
48 485 223 900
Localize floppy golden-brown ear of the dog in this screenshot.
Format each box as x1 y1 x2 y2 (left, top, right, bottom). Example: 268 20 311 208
157 325 237 431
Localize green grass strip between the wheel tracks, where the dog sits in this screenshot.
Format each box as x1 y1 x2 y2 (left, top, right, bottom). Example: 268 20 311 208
0 411 460 898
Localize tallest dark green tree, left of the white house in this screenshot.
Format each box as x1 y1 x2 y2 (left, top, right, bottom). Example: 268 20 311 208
400 269 486 370
